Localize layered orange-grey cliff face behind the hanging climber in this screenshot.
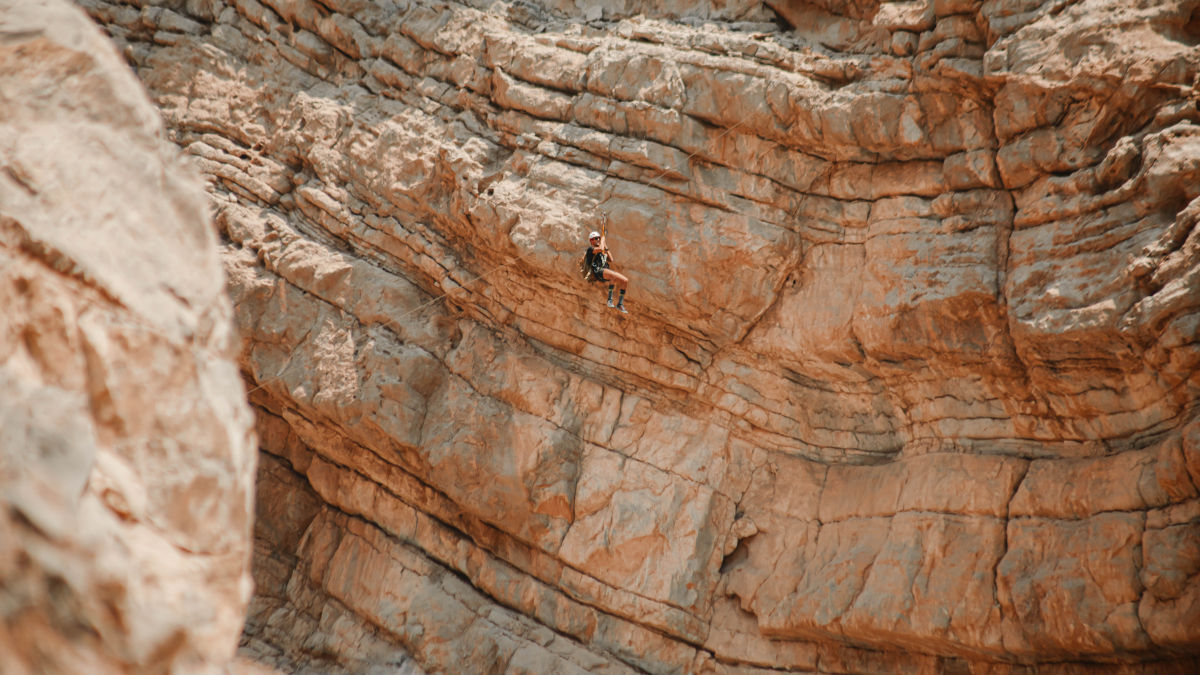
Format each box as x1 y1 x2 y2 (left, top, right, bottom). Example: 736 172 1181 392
80 0 1200 673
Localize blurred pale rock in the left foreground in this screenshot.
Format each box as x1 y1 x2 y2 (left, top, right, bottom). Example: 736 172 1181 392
0 0 257 675
